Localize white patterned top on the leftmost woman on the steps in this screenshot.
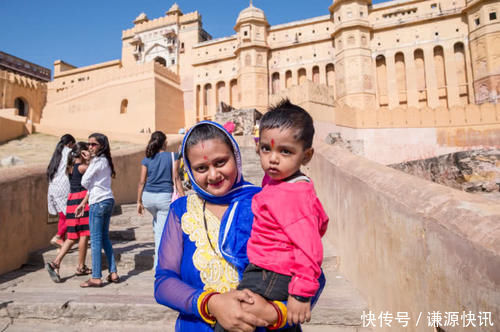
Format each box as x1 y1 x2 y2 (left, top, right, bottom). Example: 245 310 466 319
47 146 71 214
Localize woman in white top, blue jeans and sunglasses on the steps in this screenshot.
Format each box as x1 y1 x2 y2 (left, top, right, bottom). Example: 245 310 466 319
75 133 120 287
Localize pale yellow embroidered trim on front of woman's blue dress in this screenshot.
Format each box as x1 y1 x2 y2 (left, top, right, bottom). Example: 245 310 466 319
181 195 238 293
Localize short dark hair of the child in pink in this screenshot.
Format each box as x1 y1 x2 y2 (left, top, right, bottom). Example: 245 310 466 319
259 98 314 149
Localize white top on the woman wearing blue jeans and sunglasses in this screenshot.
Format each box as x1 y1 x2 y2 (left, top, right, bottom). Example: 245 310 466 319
82 156 114 205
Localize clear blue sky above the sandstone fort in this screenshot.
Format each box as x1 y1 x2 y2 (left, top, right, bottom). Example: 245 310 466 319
0 0 384 71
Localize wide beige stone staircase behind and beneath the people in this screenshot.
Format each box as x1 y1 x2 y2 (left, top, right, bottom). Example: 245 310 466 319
0 144 370 332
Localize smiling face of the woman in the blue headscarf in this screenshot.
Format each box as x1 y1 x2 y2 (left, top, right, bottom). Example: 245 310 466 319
187 139 238 196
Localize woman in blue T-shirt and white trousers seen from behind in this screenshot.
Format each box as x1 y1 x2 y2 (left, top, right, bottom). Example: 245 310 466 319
137 131 184 269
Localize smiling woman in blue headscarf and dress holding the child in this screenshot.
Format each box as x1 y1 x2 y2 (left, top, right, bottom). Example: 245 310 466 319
155 121 324 332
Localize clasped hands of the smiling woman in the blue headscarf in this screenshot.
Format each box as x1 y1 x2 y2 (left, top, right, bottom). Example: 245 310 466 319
208 290 268 332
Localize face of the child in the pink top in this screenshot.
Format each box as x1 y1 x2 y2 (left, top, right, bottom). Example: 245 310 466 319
258 128 313 180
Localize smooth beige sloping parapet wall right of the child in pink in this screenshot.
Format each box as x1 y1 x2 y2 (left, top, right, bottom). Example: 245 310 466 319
309 142 500 332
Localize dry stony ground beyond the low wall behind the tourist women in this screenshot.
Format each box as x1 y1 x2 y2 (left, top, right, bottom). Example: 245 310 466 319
0 133 141 168
